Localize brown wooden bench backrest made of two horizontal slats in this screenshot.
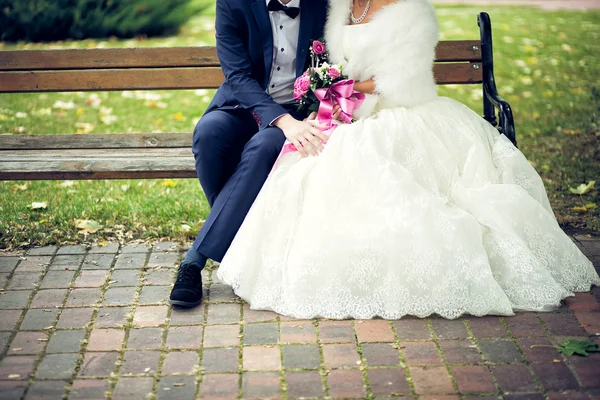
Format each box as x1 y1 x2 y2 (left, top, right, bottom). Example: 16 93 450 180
0 40 482 93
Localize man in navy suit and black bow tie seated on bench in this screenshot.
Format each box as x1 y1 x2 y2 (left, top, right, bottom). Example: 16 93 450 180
170 0 327 307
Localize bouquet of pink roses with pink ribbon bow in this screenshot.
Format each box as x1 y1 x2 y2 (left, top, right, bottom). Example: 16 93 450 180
280 40 365 156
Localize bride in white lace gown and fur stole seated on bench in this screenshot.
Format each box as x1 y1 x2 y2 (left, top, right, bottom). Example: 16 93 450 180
218 0 600 319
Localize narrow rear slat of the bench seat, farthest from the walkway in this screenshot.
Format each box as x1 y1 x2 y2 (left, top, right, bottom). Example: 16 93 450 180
0 132 192 150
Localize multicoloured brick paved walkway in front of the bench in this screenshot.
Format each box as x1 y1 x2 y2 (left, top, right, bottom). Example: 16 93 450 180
0 236 600 400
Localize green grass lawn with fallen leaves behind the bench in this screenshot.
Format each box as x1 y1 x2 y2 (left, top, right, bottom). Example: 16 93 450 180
0 7 600 248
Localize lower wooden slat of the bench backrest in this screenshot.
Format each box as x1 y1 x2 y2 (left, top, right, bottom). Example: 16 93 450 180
0 63 482 93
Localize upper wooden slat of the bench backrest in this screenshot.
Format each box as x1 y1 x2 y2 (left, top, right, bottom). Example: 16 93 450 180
0 40 481 71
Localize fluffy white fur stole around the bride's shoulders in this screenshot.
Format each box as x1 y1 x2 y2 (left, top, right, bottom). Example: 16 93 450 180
325 0 439 107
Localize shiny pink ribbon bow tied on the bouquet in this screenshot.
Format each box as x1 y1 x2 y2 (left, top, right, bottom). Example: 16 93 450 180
279 79 365 157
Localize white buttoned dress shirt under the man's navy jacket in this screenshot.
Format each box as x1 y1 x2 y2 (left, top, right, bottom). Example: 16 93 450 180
266 0 300 104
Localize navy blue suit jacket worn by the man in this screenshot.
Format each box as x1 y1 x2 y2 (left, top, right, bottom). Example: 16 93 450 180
206 0 327 129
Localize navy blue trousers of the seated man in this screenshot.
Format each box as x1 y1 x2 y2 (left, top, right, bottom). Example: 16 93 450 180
192 109 298 261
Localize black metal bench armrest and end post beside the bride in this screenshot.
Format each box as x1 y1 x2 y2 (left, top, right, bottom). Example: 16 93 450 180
477 12 517 146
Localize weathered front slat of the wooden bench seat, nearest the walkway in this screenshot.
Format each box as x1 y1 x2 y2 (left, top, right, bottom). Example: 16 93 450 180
0 148 196 180
